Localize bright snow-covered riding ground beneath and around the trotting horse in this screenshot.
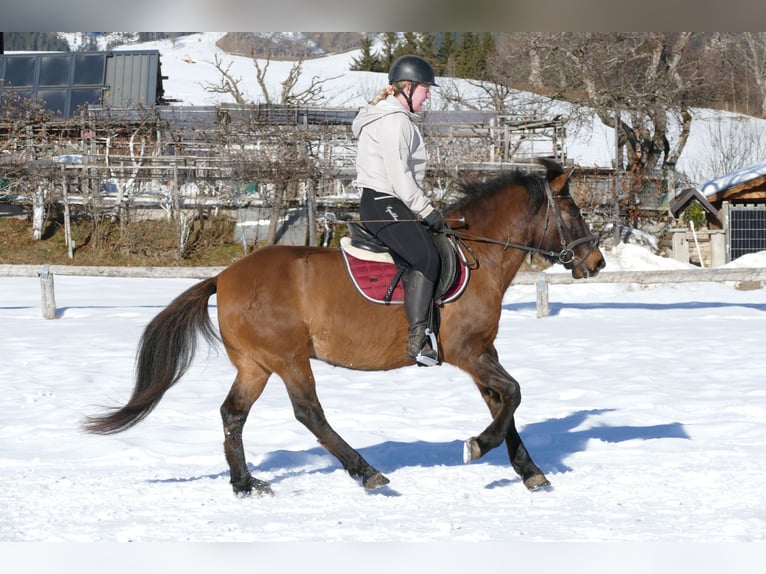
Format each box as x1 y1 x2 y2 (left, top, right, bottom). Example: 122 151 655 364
0 245 766 572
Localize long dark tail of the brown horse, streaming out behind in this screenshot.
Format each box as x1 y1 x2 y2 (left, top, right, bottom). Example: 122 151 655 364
83 277 218 434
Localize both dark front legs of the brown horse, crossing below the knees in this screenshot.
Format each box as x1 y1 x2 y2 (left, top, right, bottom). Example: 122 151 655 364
463 348 550 490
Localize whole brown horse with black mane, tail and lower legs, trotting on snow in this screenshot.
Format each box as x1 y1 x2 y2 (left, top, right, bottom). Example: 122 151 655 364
85 160 604 495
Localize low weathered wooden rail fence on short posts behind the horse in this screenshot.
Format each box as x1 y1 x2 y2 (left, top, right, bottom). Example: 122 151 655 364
0 265 766 319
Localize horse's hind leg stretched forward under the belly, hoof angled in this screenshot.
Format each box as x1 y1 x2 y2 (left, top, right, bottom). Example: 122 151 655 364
279 359 389 489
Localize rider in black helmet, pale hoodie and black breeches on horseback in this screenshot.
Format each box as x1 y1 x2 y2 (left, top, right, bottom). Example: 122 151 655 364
352 55 447 366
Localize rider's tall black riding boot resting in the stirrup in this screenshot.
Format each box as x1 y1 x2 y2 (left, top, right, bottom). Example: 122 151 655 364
404 271 439 367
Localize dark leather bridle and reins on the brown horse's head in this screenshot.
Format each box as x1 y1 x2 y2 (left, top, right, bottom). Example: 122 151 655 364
445 181 601 275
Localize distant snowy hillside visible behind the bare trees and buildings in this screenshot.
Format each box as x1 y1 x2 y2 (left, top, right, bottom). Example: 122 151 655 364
54 32 766 184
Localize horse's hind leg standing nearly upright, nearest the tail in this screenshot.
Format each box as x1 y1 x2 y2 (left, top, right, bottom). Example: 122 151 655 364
221 367 272 496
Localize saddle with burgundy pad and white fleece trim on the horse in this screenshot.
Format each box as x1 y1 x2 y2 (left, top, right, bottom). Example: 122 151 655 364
340 221 470 305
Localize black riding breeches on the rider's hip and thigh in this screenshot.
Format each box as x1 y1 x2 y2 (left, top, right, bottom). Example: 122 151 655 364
359 188 441 283
